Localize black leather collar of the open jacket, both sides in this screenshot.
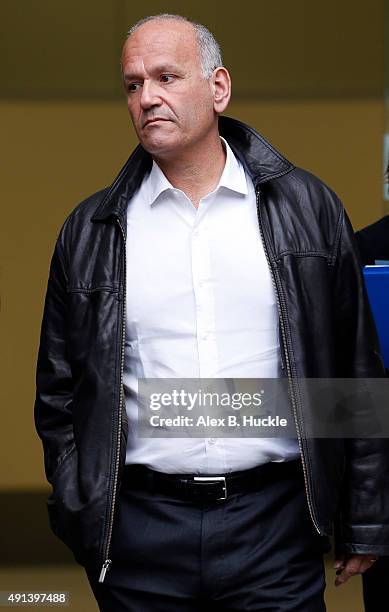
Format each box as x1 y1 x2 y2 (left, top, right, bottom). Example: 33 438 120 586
92 117 294 221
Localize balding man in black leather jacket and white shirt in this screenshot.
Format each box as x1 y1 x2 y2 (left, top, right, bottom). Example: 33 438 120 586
35 15 389 612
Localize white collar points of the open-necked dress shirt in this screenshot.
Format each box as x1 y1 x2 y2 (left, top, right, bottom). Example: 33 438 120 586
147 136 248 206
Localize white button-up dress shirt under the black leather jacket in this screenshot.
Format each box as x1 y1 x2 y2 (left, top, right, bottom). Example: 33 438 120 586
124 139 299 474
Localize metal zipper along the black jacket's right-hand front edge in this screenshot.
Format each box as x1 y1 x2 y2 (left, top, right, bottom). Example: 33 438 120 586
256 189 322 535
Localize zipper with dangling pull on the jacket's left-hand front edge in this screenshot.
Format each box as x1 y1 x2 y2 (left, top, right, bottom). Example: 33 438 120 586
99 218 127 582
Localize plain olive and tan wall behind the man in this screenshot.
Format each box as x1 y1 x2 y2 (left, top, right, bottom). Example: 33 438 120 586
0 0 384 490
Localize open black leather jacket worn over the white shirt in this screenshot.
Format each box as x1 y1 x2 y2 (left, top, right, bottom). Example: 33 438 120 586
35 117 389 580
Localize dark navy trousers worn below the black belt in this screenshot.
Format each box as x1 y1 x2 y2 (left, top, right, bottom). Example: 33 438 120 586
87 464 329 612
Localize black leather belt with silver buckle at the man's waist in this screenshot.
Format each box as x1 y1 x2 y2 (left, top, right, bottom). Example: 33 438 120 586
121 459 302 502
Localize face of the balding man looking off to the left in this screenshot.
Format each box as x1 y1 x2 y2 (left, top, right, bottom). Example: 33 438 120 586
122 20 216 159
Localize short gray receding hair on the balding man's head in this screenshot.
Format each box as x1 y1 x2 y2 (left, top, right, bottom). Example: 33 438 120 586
127 13 223 79
